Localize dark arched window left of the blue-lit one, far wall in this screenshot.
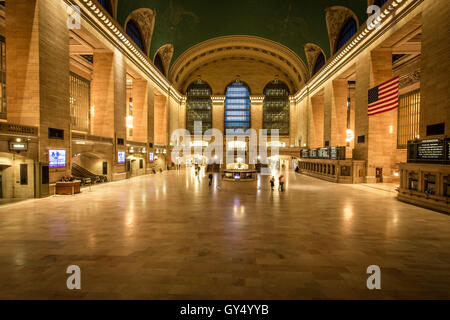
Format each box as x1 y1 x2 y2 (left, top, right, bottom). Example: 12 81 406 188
186 80 212 135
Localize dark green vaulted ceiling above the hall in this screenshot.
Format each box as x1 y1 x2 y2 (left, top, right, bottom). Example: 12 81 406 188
118 0 367 62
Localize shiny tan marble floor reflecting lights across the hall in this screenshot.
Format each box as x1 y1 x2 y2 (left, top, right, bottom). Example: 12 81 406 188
0 171 450 299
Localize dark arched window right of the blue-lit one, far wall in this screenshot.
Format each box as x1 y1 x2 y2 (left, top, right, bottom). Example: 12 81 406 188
263 80 290 136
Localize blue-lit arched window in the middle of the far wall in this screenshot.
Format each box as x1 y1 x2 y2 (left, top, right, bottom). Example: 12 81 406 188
225 81 250 134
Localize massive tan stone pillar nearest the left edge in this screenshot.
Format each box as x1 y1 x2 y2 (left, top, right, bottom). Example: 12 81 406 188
5 0 71 185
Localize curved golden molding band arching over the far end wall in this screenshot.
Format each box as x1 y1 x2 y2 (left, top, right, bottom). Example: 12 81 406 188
169 36 309 92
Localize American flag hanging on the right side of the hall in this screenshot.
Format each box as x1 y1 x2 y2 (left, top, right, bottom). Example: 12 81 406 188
368 77 399 116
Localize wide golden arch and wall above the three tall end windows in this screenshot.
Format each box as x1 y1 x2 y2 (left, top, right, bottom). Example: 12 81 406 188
169 36 309 95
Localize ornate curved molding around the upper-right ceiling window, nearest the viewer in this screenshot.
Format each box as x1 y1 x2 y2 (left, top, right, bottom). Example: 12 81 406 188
326 6 359 56
